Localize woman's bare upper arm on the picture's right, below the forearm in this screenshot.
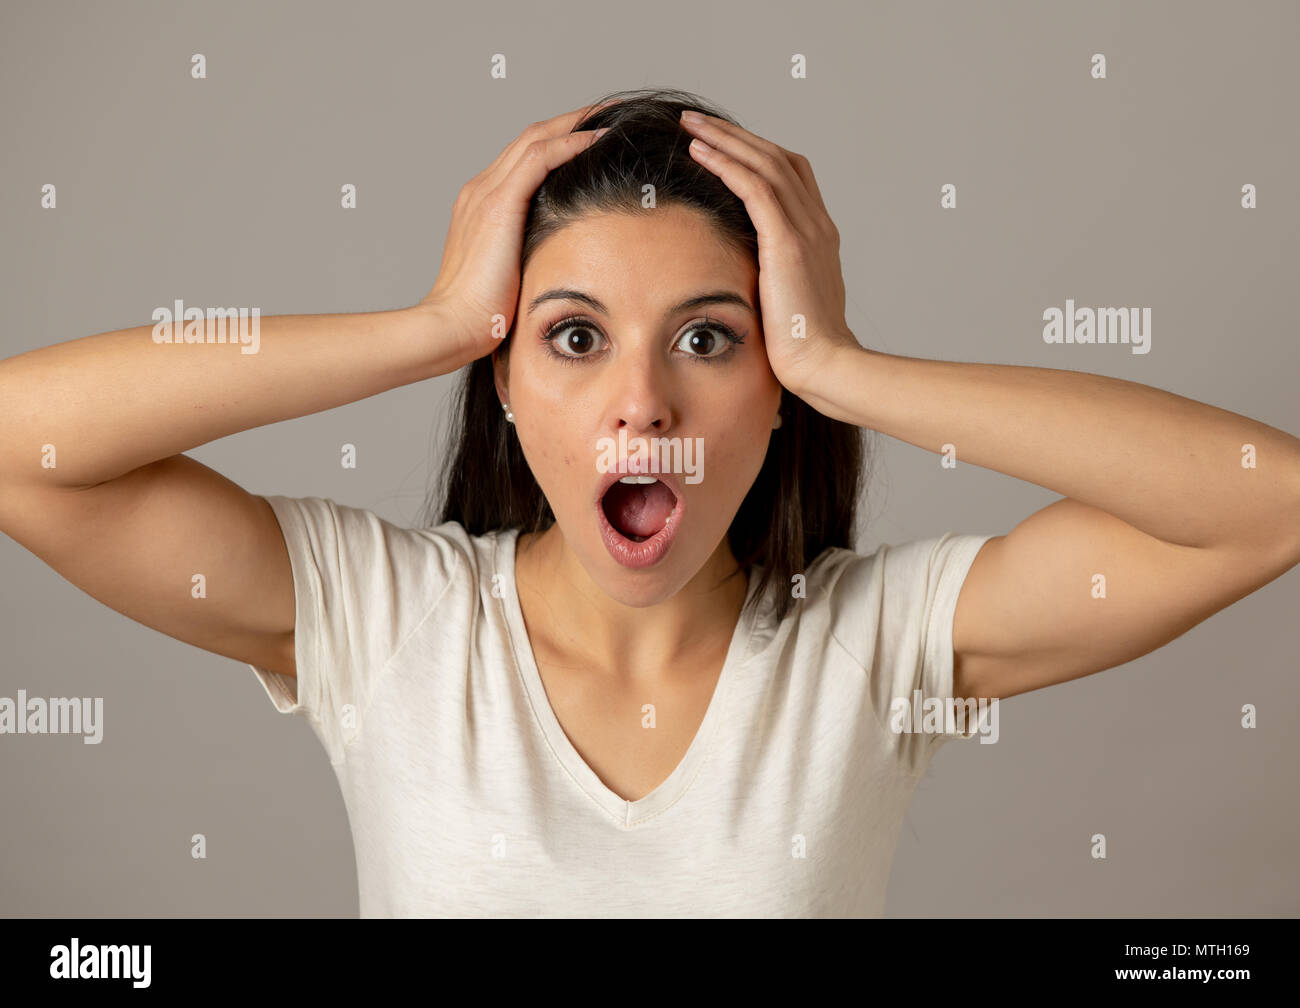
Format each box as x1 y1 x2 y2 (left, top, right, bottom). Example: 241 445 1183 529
953 497 1295 697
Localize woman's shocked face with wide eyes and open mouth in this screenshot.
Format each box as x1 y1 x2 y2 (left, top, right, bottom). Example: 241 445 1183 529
495 204 781 606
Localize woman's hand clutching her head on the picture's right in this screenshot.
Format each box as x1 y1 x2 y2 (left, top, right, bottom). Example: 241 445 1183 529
681 113 862 398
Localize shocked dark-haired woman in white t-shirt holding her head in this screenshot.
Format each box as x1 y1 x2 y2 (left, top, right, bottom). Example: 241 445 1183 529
0 91 1300 916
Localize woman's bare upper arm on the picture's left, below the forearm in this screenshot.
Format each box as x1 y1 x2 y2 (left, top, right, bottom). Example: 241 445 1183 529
0 455 295 675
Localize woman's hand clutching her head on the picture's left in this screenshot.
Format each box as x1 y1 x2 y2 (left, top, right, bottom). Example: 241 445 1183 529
415 99 602 367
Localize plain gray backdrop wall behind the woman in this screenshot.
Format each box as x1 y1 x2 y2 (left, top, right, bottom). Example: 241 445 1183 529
0 0 1300 917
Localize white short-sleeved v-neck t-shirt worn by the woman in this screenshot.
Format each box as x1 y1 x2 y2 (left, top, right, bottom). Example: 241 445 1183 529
250 497 992 917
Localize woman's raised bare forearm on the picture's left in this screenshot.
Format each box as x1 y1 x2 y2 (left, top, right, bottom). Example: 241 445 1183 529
0 301 465 488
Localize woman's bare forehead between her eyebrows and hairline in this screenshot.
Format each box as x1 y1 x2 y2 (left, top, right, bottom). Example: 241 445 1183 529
523 204 758 303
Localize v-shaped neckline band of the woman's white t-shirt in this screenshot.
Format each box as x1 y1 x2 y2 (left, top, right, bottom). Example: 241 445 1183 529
493 528 758 829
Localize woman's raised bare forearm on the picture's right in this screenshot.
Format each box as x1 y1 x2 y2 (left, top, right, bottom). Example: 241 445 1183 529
801 349 1300 548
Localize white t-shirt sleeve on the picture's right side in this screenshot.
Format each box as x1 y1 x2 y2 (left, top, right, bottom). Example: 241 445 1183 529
832 532 993 773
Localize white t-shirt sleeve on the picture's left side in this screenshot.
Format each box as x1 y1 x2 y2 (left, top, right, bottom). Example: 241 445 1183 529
248 496 467 765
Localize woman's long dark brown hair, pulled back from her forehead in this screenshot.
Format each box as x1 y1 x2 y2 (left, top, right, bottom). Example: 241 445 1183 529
424 88 866 619
